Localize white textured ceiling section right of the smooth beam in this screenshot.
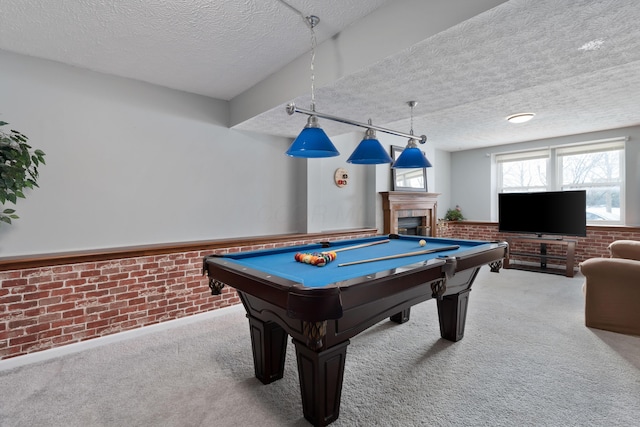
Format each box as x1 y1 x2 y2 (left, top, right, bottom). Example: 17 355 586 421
239 0 640 151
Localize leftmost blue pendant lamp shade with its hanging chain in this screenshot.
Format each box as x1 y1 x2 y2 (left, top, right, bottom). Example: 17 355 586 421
286 15 340 158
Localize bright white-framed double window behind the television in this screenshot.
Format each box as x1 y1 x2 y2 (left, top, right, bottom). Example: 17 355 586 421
495 138 626 224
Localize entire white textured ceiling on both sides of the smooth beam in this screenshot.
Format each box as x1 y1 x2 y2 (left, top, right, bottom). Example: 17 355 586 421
0 0 640 151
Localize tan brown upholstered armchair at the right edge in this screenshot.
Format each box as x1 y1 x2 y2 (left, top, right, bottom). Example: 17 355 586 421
580 240 640 335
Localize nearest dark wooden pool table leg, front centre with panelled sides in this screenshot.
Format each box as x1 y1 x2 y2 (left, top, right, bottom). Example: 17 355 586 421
293 339 349 426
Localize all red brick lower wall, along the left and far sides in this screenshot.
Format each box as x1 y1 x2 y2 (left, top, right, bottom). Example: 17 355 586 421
0 227 640 359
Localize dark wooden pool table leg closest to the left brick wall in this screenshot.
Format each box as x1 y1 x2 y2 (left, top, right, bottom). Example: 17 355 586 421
247 315 288 384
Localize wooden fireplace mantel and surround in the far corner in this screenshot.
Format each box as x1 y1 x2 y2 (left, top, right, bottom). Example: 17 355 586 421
380 191 440 236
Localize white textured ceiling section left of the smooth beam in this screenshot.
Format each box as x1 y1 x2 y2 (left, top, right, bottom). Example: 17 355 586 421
0 0 388 100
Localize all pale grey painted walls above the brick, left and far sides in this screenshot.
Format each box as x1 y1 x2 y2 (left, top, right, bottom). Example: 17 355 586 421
10 47 640 257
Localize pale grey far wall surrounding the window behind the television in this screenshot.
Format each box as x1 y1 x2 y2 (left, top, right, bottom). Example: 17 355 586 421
450 126 640 226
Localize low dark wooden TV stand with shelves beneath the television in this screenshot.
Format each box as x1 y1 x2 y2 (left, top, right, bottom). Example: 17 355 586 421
504 236 576 277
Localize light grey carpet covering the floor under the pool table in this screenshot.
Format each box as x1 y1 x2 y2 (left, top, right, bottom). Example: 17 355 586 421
0 267 640 427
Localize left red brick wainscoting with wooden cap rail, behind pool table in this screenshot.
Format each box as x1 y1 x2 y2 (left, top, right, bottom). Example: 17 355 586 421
0 230 376 359
